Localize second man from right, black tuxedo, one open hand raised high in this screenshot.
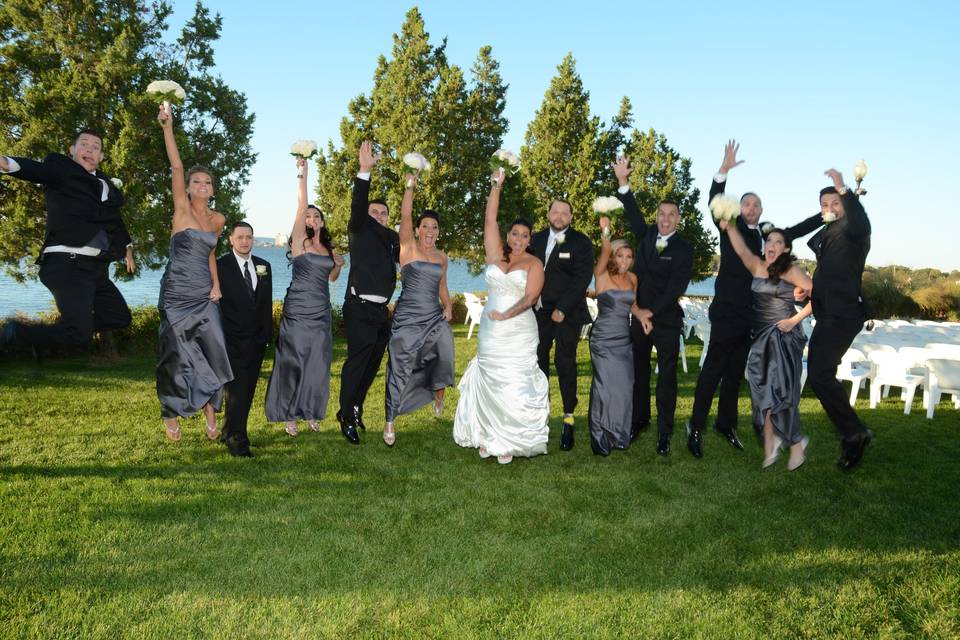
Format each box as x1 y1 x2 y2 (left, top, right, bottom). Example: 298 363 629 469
687 140 823 458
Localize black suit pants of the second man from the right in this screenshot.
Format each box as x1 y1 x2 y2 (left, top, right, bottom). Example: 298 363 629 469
688 328 750 431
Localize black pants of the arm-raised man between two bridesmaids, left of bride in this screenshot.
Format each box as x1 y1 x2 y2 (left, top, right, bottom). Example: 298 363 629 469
340 297 390 415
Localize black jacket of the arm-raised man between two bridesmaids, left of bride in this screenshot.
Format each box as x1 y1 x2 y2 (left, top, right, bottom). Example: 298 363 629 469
346 178 400 300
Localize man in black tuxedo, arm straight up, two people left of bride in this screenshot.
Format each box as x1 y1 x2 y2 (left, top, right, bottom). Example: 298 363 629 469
337 141 400 444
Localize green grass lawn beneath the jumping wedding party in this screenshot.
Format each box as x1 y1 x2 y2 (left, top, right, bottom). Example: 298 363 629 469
0 328 960 638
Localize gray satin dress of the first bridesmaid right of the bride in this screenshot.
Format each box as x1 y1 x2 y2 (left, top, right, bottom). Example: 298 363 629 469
590 289 635 454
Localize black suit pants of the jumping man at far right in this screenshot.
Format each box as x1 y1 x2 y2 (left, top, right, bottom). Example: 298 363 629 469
807 317 866 439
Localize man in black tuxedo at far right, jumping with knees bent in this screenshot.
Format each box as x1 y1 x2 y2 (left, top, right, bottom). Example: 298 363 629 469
807 169 873 471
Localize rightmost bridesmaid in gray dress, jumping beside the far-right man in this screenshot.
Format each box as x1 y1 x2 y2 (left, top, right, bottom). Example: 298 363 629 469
719 220 813 471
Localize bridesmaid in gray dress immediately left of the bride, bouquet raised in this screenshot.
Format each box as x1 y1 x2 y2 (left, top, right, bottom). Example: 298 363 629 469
383 175 453 447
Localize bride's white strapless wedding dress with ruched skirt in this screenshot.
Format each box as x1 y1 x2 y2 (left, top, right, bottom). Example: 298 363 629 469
453 264 550 457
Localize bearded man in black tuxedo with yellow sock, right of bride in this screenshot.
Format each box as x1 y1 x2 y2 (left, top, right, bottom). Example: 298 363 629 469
530 199 593 451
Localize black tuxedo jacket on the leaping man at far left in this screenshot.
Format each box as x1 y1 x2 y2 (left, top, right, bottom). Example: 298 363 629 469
10 153 130 260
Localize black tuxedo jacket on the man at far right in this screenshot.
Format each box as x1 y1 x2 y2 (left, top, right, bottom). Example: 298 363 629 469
807 191 872 322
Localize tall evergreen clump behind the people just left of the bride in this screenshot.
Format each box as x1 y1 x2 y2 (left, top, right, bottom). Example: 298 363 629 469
317 8 507 262
